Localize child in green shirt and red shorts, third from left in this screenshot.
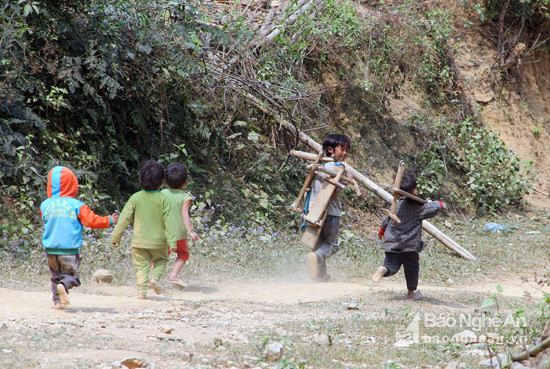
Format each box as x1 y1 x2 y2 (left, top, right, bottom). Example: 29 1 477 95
162 163 199 288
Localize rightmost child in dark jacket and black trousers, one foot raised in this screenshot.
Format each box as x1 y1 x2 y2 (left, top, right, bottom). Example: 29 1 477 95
371 173 447 300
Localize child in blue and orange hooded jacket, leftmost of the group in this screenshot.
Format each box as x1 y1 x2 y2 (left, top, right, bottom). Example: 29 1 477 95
40 166 118 309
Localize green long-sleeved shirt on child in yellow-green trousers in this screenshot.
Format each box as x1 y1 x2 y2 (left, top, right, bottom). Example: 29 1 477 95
111 190 176 249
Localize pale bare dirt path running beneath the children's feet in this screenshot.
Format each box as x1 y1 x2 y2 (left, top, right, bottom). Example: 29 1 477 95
0 278 542 320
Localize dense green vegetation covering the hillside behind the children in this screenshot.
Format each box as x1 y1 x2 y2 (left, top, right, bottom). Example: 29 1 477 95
0 0 548 228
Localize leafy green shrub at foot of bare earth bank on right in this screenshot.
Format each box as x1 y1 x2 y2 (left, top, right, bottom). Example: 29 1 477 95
417 118 533 213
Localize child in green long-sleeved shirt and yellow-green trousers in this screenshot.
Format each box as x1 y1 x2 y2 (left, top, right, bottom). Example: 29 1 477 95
111 160 175 299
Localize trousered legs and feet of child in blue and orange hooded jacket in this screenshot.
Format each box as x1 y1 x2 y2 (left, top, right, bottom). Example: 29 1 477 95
46 255 80 304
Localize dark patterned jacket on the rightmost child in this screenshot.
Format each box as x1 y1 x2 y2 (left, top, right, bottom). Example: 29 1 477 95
380 197 443 252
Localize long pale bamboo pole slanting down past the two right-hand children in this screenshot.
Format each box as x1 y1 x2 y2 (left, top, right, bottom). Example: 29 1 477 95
242 91 476 260
